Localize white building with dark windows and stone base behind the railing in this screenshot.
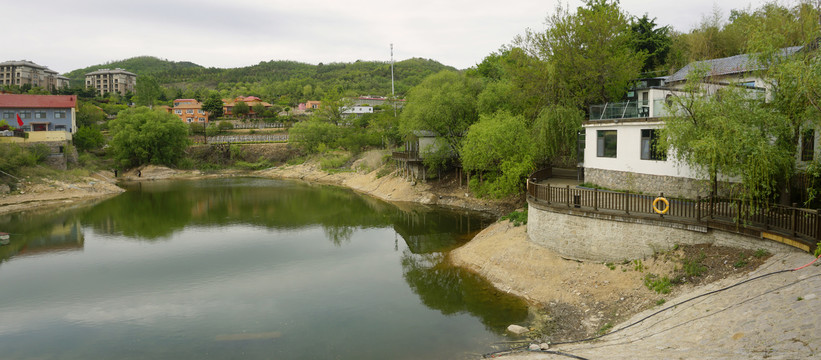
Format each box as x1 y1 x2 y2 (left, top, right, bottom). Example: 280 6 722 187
579 47 804 198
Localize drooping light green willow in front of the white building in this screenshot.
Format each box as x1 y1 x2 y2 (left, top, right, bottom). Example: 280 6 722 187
660 69 795 203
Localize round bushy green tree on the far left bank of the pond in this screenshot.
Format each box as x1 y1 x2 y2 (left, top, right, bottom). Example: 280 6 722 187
109 107 190 166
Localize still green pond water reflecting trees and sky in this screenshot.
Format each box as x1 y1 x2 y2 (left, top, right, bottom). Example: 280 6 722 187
0 179 527 359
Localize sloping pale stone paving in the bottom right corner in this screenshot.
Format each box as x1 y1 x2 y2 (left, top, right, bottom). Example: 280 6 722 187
494 253 821 360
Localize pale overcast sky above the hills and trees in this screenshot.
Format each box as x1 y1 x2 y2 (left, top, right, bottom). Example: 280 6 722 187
8 0 784 73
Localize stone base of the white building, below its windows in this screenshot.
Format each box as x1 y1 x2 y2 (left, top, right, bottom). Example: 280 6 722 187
584 168 710 199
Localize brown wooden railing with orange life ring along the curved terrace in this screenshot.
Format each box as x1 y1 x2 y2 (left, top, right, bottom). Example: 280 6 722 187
527 171 821 249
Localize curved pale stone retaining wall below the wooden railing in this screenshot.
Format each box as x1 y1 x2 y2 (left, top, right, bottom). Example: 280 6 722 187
527 202 800 262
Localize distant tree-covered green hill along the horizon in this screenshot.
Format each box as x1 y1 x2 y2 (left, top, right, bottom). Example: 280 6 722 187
66 56 456 103
